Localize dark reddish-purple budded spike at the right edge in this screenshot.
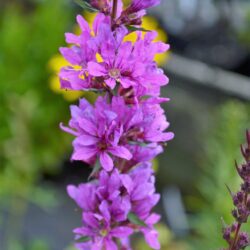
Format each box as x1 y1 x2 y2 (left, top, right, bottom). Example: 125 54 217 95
223 131 250 250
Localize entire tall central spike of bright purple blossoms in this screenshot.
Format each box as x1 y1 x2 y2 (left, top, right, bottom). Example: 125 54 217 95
59 0 174 250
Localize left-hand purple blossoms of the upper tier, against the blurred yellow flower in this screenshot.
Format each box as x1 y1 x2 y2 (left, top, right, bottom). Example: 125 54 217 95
59 14 110 90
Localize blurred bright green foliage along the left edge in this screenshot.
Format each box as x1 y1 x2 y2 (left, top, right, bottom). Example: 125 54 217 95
0 0 74 250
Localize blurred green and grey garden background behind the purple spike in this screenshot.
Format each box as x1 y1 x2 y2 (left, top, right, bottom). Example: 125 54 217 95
0 0 250 250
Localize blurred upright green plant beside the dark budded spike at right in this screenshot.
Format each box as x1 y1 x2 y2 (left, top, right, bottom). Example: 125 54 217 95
188 101 250 250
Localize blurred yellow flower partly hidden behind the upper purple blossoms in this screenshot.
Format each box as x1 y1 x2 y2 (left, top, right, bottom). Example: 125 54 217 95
49 12 169 102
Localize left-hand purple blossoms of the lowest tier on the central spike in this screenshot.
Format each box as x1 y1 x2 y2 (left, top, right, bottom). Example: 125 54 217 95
67 171 133 250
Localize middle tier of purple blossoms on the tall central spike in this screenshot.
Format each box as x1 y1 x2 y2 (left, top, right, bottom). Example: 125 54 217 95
61 97 174 171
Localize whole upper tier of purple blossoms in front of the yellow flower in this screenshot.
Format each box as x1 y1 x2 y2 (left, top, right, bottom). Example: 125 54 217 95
59 13 169 100
